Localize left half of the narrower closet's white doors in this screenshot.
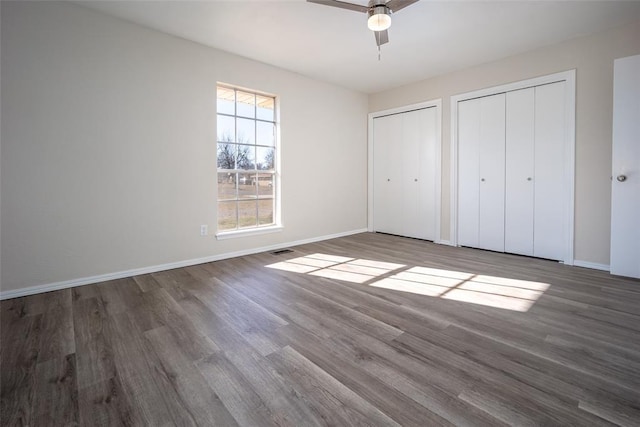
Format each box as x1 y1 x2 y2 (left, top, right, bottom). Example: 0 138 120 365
373 115 402 234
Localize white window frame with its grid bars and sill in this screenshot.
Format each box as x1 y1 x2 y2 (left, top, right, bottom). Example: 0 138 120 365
215 82 284 240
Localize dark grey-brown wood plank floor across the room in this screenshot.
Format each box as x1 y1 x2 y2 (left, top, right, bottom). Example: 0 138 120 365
0 233 640 426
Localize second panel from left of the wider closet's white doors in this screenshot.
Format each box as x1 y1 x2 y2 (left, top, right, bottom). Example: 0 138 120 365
478 93 505 252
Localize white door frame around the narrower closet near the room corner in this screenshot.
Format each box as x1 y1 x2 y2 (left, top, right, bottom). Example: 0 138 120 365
367 98 442 243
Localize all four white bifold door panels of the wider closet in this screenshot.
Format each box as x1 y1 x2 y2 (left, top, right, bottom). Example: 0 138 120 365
458 81 570 260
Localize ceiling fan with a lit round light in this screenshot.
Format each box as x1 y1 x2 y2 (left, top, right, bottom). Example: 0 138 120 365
307 0 418 50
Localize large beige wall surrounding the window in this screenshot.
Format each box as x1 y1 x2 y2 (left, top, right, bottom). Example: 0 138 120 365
1 2 367 293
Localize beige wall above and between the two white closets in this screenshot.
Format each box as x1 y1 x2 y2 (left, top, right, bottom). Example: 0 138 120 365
369 23 640 265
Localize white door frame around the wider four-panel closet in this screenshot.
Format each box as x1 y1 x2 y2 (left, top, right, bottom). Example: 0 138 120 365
449 69 576 265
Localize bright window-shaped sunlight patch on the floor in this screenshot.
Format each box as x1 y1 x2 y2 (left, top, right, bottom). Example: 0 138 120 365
266 254 549 312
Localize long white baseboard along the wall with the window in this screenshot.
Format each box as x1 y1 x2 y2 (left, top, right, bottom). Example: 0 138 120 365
0 228 367 300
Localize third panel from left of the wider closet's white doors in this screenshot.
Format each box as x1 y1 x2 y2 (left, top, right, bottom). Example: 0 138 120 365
504 88 535 255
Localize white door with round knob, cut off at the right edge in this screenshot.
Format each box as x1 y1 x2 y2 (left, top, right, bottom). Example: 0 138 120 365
611 55 640 278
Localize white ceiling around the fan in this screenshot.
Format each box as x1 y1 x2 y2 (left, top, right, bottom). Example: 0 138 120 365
76 0 640 93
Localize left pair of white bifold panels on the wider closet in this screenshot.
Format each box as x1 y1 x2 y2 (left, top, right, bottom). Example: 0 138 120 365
458 94 505 251
